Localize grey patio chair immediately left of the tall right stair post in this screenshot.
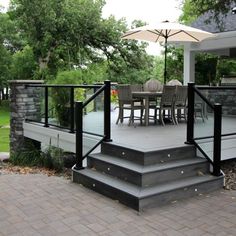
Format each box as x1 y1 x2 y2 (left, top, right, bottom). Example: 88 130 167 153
172 86 188 124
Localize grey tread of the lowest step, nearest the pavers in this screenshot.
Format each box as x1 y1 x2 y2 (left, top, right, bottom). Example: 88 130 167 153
74 168 223 199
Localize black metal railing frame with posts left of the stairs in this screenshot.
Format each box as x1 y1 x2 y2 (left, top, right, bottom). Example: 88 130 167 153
26 81 111 169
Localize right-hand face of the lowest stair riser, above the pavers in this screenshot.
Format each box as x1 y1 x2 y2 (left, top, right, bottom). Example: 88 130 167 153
139 178 224 210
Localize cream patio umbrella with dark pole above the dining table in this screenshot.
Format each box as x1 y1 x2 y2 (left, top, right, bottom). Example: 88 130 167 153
122 21 214 84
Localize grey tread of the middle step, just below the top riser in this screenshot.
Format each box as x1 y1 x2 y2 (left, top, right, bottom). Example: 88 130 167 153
90 153 207 173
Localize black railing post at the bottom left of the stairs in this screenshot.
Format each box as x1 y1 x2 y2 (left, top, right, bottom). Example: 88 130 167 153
75 102 83 170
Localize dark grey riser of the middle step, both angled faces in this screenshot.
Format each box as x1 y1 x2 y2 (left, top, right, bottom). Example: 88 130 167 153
87 157 209 187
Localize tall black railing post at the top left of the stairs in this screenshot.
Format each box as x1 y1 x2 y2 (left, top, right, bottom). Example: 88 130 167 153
104 80 112 142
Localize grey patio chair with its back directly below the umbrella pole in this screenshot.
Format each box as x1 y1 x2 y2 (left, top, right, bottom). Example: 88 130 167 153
155 85 176 125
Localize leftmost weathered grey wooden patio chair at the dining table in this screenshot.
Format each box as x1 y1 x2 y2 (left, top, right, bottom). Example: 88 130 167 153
116 84 144 125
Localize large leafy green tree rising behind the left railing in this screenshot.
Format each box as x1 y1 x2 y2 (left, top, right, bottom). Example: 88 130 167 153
9 0 153 83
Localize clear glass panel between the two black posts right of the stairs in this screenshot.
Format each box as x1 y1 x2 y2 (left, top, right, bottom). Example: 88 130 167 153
193 93 214 160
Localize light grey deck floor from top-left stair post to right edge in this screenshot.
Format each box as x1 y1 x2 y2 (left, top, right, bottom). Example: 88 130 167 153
109 109 236 160
